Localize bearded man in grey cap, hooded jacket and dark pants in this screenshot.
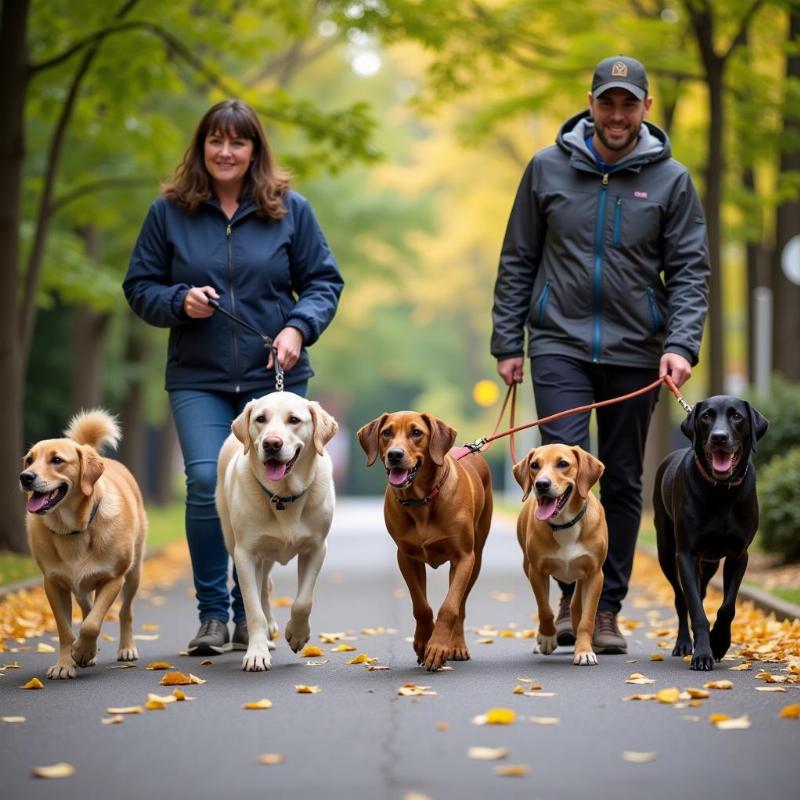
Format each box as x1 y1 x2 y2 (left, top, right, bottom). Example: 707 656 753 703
491 56 709 653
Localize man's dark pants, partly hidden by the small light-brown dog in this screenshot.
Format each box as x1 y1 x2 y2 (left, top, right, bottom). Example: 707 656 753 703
531 356 658 614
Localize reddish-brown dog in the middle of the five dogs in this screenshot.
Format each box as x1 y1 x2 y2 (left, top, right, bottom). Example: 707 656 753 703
358 411 492 670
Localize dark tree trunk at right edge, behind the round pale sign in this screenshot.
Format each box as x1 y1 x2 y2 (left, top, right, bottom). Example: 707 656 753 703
772 11 800 381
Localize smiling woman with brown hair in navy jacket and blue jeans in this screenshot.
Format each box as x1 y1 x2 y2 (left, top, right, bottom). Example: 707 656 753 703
123 100 343 656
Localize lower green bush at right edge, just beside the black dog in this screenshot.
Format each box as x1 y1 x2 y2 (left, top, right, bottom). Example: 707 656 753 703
758 445 800 560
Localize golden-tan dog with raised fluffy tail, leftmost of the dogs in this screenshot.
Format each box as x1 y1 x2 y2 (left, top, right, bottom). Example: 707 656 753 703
19 409 147 678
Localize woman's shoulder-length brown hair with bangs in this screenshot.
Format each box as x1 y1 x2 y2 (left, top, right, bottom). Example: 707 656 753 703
161 100 290 219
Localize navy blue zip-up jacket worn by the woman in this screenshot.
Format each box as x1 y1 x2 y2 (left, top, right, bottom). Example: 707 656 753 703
123 192 344 392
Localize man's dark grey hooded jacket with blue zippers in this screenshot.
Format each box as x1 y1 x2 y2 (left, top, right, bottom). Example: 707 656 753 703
491 111 709 367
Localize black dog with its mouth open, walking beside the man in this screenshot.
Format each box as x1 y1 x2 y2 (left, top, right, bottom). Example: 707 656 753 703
653 395 768 670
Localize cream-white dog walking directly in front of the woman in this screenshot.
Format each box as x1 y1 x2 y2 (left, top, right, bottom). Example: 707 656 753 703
216 392 337 672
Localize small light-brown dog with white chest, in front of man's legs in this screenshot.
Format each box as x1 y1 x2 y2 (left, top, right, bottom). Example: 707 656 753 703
514 444 608 665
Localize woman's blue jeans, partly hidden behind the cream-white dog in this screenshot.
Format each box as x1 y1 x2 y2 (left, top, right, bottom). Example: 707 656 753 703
169 381 308 622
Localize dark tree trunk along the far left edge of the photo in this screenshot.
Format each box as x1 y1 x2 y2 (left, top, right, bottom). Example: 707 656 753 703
0 0 28 553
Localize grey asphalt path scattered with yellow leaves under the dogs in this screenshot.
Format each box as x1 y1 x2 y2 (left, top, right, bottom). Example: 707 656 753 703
0 500 800 800
